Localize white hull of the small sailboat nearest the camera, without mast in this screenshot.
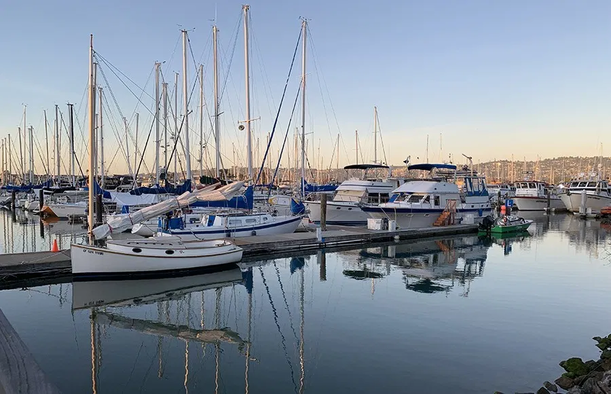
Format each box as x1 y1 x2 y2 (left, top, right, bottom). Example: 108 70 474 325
71 238 243 276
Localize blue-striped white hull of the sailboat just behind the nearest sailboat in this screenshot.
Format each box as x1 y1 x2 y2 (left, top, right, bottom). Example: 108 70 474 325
159 216 301 241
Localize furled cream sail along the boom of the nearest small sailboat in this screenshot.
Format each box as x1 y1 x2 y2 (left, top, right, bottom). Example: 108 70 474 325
91 182 244 239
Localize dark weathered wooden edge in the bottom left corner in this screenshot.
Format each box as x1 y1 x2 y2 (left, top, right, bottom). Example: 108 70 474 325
0 310 60 394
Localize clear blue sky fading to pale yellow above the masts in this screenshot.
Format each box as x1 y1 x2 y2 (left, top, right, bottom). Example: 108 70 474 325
0 0 611 174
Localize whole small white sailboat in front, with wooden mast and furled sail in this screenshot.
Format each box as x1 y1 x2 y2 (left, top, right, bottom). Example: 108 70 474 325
71 36 242 276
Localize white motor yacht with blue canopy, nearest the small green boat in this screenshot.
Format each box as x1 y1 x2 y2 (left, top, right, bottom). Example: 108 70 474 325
362 163 492 228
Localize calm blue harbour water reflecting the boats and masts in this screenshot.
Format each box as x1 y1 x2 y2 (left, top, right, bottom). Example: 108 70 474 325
0 214 611 393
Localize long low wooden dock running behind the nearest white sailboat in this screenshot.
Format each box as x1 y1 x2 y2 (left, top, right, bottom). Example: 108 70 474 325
0 224 477 289
